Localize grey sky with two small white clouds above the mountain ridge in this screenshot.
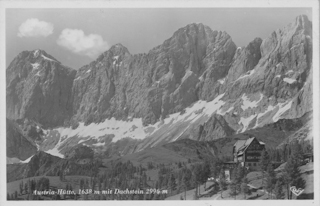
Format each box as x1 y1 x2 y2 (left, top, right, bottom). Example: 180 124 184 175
6 8 312 69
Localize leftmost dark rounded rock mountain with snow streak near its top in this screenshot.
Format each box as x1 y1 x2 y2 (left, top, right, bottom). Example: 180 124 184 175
6 50 76 127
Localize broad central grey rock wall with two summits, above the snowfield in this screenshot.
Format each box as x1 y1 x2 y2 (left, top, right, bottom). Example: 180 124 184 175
73 24 236 125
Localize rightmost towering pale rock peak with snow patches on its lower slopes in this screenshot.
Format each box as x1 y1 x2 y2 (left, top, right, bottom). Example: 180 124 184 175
221 16 312 131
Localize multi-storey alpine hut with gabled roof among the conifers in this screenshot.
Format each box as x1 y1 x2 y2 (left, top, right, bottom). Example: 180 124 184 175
233 137 265 170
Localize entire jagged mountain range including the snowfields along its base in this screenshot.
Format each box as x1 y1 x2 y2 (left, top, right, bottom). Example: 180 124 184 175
7 16 312 159
